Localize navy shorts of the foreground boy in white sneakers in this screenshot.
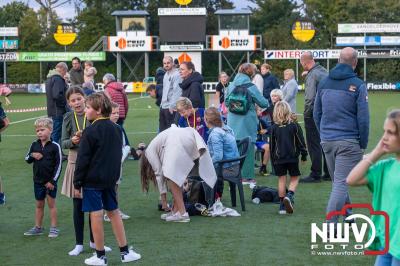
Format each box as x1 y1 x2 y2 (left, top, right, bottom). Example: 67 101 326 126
82 188 118 212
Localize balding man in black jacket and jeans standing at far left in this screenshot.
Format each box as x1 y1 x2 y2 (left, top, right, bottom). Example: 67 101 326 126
45 62 68 143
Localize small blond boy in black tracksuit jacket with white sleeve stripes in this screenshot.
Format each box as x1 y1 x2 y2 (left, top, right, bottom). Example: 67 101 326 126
24 118 62 237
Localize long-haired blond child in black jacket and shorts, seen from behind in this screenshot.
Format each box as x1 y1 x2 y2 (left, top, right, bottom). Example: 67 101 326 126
271 101 307 214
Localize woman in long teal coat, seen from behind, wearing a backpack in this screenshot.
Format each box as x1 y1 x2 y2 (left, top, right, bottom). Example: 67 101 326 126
226 63 269 184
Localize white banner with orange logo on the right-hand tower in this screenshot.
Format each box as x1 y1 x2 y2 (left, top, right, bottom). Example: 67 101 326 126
210 34 257 51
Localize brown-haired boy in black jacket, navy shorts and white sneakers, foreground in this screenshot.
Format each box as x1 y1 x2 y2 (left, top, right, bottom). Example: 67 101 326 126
74 93 141 265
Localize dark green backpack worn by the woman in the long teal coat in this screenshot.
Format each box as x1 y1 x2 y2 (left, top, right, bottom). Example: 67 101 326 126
225 83 253 115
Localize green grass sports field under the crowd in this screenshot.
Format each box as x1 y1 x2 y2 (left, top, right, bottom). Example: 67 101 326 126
0 92 400 265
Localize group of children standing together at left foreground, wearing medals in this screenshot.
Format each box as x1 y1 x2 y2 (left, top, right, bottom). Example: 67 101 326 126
25 87 141 265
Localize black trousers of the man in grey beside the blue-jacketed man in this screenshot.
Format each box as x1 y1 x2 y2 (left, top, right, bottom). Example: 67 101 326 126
304 117 329 178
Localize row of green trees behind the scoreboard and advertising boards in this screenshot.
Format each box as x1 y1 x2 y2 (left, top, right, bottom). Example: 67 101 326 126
0 0 400 83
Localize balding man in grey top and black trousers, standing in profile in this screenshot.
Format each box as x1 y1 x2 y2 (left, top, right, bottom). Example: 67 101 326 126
300 52 331 183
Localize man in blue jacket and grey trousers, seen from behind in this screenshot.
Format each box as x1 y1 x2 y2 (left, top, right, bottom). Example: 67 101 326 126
313 47 369 223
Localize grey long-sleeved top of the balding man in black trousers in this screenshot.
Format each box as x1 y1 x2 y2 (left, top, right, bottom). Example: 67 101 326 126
304 63 328 118
